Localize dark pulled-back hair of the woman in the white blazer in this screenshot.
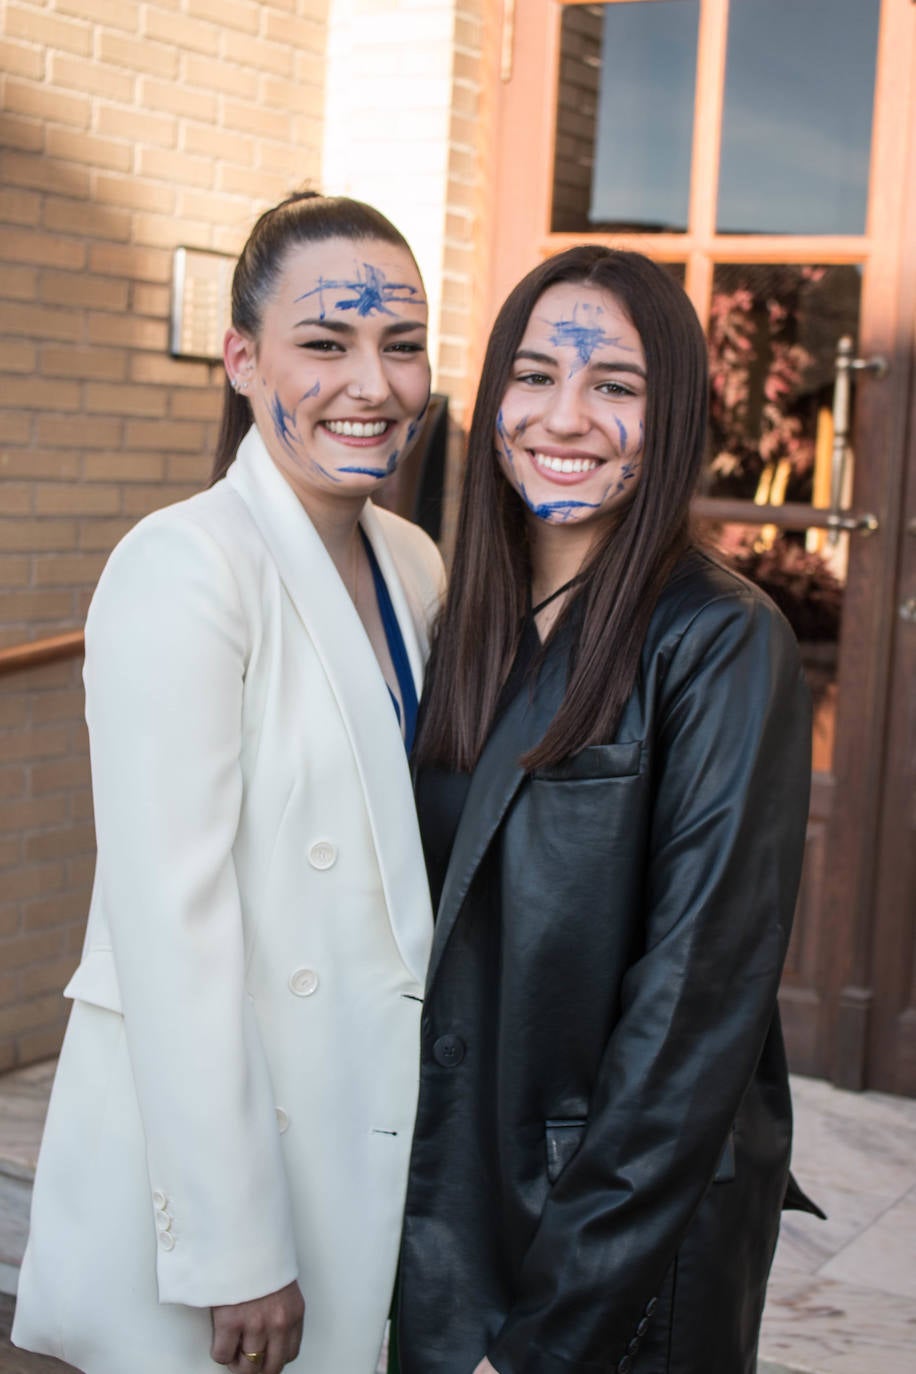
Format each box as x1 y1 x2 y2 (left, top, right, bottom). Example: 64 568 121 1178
210 191 415 484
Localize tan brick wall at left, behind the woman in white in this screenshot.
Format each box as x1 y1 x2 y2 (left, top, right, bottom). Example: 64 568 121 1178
0 0 328 1070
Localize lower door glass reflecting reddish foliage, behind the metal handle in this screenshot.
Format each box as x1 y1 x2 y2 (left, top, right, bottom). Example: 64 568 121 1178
703 264 861 771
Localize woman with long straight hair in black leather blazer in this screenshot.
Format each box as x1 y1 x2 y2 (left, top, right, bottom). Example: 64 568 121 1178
400 246 810 1374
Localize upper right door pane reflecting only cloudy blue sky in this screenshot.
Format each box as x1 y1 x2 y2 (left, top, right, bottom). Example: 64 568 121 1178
719 0 880 234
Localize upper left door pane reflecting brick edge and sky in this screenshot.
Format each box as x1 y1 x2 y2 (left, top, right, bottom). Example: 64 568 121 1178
551 0 699 234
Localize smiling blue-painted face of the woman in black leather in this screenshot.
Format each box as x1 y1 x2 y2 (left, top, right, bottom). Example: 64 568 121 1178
496 282 645 532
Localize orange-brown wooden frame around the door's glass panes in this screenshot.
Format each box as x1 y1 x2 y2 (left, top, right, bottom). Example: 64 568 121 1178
489 0 916 1087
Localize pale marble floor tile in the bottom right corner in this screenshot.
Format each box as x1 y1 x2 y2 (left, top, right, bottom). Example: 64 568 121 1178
761 1274 916 1374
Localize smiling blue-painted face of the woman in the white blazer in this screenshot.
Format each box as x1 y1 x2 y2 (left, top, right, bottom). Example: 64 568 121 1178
225 238 430 508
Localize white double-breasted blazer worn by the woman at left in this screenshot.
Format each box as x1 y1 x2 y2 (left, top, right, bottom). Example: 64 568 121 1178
12 430 442 1374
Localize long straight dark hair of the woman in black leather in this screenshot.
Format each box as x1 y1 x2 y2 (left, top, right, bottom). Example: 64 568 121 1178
415 245 707 769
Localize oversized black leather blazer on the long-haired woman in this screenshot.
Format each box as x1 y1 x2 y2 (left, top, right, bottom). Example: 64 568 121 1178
400 552 810 1374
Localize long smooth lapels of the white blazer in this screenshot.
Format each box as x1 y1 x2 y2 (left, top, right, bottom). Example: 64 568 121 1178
225 429 433 984
